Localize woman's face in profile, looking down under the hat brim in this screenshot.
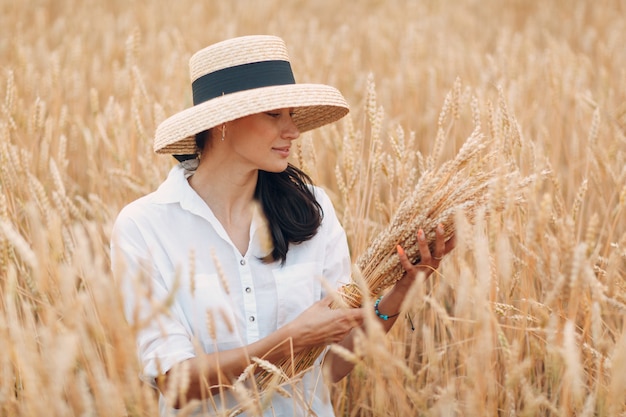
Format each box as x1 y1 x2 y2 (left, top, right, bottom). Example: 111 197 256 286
223 109 300 172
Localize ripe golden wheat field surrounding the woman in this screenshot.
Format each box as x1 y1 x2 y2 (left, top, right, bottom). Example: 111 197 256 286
0 0 626 417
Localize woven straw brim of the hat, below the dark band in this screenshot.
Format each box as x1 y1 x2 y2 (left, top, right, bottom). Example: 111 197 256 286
154 84 349 155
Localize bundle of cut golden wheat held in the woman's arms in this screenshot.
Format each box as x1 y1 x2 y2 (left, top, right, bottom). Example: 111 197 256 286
257 129 520 389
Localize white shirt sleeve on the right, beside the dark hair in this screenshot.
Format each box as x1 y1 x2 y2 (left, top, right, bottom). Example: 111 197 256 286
315 187 351 296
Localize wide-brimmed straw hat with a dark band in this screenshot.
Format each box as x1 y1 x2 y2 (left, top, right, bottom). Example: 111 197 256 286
154 36 348 155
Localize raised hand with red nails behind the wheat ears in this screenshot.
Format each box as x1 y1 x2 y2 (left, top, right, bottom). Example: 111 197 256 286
398 224 456 282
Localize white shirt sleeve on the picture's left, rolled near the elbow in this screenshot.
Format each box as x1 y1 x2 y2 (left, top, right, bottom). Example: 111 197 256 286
111 205 196 386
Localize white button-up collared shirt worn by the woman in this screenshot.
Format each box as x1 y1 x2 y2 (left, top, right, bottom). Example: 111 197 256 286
111 165 350 416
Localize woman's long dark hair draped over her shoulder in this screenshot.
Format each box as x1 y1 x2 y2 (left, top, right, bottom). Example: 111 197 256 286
192 131 324 264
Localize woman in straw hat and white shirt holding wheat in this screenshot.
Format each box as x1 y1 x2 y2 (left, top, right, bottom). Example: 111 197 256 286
111 36 452 416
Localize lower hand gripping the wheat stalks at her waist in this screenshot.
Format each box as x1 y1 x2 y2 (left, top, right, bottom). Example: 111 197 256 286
288 296 364 352
